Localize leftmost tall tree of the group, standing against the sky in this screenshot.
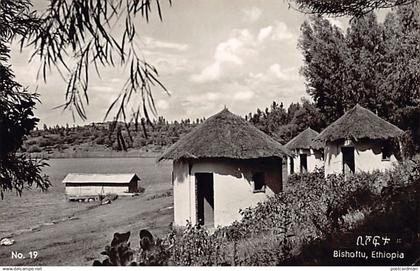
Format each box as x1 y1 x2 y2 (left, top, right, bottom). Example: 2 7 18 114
298 16 349 122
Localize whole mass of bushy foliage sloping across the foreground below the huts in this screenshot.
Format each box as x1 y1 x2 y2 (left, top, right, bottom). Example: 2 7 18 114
94 160 420 266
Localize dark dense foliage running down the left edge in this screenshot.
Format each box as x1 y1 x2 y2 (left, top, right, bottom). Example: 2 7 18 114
0 1 50 199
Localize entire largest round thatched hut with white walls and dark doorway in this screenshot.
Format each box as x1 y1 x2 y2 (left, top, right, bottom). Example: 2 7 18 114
158 109 288 227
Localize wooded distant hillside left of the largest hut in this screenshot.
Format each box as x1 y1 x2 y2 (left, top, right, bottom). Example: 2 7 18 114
22 117 203 157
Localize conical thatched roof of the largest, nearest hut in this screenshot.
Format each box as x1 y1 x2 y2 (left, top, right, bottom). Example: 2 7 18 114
158 109 289 161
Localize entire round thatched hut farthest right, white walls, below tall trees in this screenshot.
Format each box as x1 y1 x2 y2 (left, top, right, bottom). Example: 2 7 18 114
315 104 403 175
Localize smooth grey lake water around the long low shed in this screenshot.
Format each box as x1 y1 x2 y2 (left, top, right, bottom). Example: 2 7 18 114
0 158 172 238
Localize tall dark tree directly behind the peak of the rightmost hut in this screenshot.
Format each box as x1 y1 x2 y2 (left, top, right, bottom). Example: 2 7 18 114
337 13 389 118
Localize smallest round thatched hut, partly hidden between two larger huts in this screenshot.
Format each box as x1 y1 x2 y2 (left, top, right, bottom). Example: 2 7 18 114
285 127 324 174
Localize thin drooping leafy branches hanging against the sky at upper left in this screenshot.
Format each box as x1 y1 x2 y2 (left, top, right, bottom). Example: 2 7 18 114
21 0 171 125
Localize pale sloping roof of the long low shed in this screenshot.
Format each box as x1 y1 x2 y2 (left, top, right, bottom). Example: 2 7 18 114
63 173 140 183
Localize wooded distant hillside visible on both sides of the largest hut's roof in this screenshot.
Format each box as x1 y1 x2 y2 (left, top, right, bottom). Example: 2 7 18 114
22 100 325 157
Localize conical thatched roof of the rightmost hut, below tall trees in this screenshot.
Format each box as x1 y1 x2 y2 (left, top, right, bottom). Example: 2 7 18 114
315 104 403 142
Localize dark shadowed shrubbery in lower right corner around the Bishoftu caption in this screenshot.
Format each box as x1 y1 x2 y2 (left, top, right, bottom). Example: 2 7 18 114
285 160 420 265
